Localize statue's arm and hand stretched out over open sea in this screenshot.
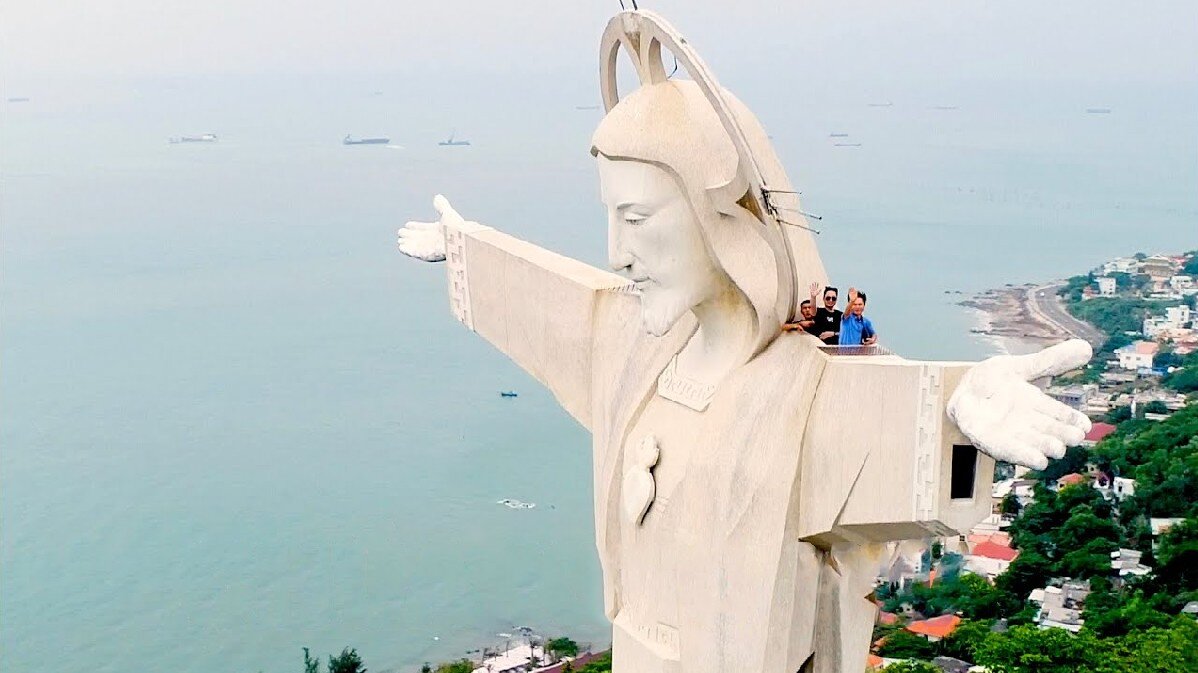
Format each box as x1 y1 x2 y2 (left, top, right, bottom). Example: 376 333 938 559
399 195 627 429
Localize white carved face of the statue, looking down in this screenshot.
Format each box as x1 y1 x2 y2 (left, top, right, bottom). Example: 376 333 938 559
598 154 731 337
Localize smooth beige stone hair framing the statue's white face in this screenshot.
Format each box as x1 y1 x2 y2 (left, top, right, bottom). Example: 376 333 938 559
591 80 785 357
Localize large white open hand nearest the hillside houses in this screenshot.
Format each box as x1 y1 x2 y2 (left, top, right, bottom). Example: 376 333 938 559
948 339 1094 469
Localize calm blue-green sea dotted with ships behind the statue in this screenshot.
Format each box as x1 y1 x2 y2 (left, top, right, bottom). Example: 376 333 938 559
0 64 1198 673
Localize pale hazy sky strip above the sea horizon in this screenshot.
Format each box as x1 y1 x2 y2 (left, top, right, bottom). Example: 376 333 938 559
0 0 1198 84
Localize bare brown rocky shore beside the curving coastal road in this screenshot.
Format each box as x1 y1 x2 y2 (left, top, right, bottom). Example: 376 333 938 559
957 283 1073 356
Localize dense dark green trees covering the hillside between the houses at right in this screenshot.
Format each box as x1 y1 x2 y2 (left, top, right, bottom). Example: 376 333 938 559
876 397 1198 673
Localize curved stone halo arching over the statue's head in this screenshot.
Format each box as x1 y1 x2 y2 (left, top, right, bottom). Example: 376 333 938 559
599 10 798 322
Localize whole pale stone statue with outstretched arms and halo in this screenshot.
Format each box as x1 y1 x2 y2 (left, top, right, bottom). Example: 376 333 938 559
399 11 1089 673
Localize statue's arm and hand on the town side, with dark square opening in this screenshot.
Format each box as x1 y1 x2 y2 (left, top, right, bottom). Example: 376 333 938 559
799 340 1090 544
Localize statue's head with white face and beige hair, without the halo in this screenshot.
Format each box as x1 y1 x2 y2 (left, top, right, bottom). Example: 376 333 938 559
591 80 781 342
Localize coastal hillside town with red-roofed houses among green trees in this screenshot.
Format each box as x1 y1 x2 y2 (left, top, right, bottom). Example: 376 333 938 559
869 251 1198 673
